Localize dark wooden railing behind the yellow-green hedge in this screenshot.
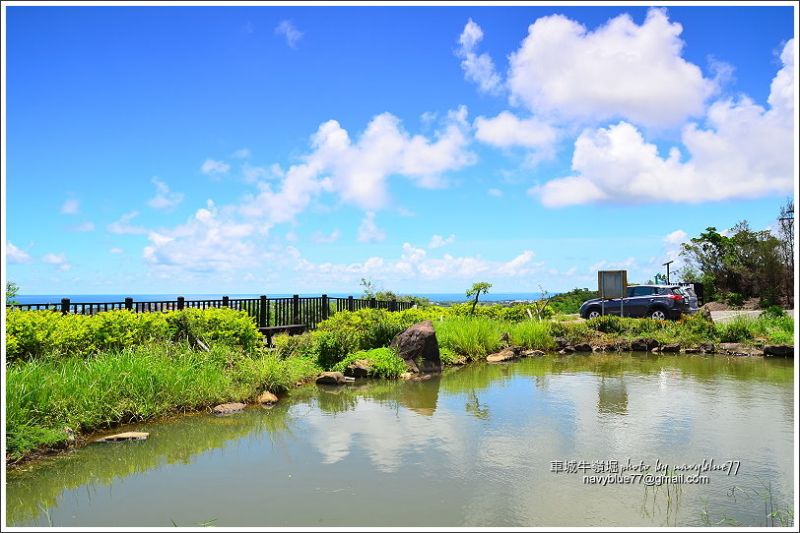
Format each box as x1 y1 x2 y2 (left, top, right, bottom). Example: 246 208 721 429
7 294 414 330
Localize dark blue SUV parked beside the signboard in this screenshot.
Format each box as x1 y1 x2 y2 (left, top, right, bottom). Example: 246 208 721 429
580 285 692 320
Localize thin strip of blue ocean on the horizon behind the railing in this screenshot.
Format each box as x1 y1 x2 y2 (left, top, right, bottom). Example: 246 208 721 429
15 292 541 304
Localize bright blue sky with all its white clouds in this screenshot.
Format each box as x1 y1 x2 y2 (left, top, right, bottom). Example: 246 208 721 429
4 6 796 294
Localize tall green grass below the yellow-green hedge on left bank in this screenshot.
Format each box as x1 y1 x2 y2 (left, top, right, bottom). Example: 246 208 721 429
6 343 319 458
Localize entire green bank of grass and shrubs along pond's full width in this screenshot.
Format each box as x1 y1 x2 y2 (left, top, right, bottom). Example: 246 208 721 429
6 306 794 460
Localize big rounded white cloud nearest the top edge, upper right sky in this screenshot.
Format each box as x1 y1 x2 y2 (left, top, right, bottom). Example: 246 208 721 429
508 9 716 127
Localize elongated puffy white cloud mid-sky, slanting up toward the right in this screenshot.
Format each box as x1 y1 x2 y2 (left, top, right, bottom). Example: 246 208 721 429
241 107 474 225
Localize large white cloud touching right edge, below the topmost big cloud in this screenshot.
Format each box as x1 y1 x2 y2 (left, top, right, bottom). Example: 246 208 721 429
531 40 796 207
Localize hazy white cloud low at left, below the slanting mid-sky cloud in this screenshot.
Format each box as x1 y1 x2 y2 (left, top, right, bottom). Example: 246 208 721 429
142 200 261 272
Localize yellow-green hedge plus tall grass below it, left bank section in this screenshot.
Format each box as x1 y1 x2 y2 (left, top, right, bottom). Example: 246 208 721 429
6 309 320 460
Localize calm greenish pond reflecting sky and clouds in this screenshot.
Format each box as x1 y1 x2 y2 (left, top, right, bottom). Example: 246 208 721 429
6 354 794 527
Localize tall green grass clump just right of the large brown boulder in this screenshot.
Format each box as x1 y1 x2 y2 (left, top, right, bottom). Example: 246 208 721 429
434 317 509 359
